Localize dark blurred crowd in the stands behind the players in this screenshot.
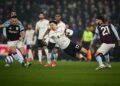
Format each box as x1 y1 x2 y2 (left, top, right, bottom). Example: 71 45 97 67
0 0 120 60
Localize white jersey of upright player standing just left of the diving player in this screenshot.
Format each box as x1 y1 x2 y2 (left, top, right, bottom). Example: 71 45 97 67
35 19 49 39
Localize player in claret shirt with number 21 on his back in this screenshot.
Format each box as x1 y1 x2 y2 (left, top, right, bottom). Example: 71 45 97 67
90 16 120 70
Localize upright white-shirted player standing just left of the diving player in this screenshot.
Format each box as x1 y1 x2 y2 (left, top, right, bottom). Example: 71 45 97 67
35 12 51 64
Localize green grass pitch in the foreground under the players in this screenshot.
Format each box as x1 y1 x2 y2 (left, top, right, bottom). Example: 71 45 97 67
0 61 120 86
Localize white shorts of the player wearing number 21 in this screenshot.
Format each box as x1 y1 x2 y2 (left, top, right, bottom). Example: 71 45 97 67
97 43 115 55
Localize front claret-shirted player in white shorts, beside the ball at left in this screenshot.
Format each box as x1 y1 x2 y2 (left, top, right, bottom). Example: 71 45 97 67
0 16 30 67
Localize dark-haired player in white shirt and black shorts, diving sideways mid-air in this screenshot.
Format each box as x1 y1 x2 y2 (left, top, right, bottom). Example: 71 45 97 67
44 21 87 57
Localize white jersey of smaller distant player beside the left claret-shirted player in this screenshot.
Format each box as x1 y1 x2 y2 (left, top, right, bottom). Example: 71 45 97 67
25 29 35 45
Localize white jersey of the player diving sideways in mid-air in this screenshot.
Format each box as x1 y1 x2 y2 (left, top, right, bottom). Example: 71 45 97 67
48 29 70 49
